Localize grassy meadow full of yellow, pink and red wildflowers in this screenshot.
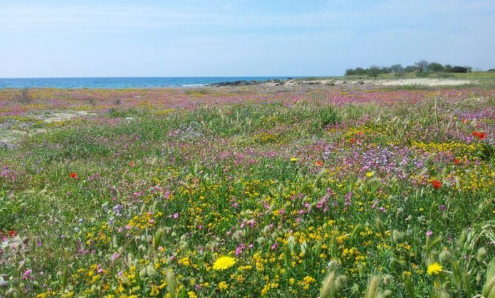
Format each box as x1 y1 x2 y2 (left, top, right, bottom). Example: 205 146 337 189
0 80 495 298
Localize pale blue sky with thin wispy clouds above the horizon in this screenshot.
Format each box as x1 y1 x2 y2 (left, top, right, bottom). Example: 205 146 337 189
0 0 495 78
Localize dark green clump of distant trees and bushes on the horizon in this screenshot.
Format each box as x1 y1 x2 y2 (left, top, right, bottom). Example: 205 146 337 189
345 60 473 78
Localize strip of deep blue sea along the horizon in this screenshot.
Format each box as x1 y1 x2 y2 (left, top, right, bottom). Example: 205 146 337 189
0 77 296 89
